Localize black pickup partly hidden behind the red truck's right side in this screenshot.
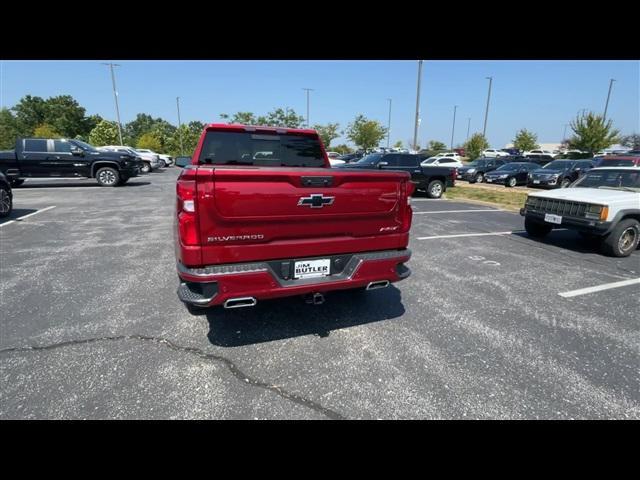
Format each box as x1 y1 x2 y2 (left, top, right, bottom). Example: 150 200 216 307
333 153 456 198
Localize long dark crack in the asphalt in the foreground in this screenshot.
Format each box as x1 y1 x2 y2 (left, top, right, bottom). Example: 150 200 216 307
0 335 346 420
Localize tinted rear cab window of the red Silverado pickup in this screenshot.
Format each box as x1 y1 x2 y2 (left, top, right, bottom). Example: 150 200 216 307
198 130 326 168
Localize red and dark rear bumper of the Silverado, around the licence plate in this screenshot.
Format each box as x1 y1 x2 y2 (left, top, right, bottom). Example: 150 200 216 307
177 249 411 307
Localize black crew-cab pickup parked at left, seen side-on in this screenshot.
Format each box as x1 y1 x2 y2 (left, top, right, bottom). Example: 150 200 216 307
0 138 142 187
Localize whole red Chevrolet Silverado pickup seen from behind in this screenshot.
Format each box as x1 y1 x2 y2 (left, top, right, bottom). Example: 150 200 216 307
174 124 414 308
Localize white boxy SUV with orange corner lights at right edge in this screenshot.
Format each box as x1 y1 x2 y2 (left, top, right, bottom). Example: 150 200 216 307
520 167 640 257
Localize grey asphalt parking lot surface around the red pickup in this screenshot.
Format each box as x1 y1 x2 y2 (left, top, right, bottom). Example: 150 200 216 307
0 168 640 419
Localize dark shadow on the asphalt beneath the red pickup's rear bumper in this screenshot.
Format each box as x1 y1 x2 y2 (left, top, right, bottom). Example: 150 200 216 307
199 285 405 347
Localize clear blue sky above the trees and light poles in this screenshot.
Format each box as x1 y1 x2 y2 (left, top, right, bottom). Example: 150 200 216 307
0 60 640 148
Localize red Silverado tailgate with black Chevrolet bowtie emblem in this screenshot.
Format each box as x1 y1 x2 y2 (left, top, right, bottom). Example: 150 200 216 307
196 166 412 265
